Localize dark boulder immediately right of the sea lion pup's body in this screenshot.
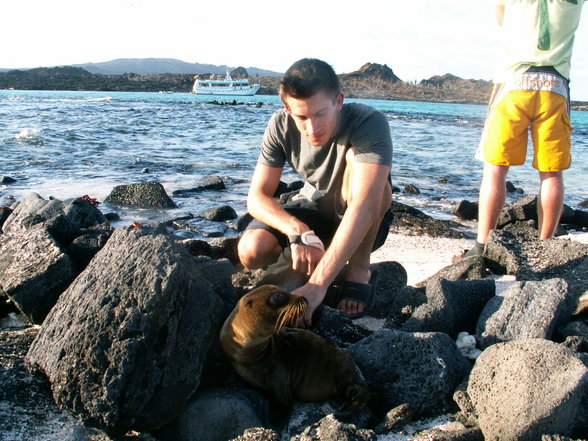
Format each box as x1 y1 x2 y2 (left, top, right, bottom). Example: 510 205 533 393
347 330 471 416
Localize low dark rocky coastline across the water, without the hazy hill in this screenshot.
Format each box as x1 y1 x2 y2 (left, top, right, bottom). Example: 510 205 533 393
0 63 588 111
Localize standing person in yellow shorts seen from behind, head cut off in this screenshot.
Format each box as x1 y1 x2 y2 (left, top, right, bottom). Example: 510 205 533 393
464 0 584 257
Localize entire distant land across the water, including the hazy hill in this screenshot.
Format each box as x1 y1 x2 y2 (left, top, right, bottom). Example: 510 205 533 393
0 59 588 110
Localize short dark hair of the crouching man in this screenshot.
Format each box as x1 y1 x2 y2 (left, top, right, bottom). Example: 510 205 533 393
280 58 341 103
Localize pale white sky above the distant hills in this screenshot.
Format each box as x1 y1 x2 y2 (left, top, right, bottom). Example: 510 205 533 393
0 0 588 101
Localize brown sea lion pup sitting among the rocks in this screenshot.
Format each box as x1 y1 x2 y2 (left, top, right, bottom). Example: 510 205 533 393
220 285 369 416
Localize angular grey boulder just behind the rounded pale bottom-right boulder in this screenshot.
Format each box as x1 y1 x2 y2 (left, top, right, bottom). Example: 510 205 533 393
476 279 575 349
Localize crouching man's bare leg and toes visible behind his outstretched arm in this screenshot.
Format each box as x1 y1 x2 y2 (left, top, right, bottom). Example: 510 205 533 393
337 149 392 314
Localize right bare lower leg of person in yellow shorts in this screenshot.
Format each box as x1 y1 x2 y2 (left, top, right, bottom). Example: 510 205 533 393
537 172 564 239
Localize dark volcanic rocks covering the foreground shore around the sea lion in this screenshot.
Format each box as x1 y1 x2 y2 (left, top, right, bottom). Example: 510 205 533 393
0 179 588 441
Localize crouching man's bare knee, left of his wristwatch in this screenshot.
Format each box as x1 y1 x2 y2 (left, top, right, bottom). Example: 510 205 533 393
237 229 282 269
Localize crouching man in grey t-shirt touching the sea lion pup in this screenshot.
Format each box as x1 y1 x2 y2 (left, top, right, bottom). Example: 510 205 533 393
238 58 392 324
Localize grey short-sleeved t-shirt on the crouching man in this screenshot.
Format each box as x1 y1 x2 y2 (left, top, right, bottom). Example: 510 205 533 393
258 103 392 218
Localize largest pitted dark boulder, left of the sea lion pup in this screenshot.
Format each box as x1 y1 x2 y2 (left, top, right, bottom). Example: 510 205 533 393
26 228 222 436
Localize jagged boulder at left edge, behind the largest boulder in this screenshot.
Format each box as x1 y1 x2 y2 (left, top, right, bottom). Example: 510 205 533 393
0 193 110 324
